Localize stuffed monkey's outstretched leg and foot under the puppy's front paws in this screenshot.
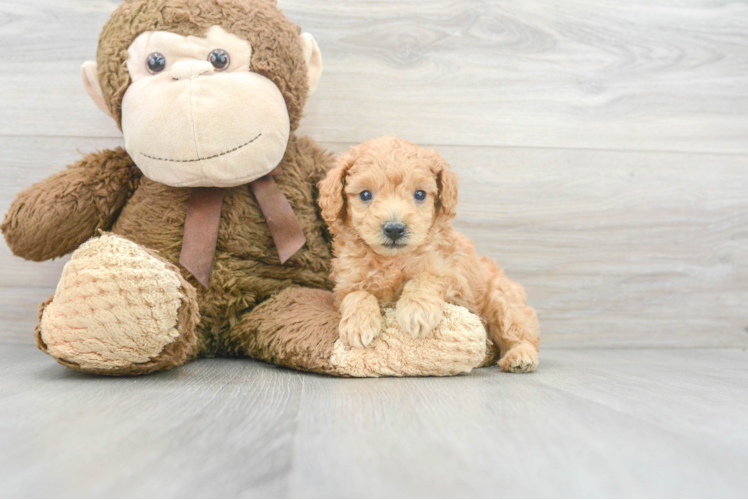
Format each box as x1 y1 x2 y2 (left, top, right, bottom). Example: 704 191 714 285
230 287 495 377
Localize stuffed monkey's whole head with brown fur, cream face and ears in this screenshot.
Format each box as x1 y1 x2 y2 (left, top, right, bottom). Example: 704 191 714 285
82 0 322 187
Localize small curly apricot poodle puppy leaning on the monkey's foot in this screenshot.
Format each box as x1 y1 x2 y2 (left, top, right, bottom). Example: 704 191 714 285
319 136 539 373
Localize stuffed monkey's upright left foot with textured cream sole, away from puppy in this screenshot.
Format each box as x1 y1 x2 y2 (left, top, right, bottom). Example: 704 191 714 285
36 233 199 375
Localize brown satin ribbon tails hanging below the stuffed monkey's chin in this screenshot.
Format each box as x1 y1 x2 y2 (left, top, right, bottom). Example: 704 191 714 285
179 167 306 288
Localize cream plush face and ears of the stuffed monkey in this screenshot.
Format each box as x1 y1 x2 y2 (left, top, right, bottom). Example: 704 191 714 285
83 4 322 187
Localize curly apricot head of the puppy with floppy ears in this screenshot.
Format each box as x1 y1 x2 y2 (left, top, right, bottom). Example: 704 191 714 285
319 136 457 255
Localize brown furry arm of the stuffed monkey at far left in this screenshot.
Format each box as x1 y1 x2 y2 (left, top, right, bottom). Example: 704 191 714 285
0 148 141 261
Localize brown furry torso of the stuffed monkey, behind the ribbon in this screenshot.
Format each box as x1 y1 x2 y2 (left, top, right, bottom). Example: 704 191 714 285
112 138 332 356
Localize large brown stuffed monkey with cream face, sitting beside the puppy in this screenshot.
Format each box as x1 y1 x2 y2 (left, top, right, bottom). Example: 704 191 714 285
2 0 496 376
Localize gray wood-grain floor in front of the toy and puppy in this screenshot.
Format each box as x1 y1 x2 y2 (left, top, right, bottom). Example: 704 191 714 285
0 345 748 498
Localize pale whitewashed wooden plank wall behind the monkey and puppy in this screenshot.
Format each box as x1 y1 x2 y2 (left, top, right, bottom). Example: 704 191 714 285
0 0 748 348
